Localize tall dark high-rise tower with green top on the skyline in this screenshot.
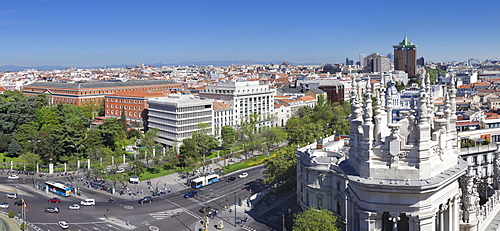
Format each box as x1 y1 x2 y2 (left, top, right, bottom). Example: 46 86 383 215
392 35 417 77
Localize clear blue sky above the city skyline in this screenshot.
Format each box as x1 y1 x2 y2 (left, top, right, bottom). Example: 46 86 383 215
0 0 500 67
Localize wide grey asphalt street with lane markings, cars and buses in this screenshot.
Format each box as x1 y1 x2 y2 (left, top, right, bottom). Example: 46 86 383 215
0 167 290 231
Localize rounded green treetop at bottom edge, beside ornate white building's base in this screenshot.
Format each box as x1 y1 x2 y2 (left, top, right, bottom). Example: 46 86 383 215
292 207 340 231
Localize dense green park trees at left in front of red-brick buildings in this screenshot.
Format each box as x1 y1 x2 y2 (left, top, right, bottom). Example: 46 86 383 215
0 91 161 171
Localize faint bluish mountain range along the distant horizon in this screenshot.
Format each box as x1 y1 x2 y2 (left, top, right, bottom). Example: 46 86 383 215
0 60 324 71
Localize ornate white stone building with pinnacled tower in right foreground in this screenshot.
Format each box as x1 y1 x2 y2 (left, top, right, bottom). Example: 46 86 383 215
297 76 500 231
